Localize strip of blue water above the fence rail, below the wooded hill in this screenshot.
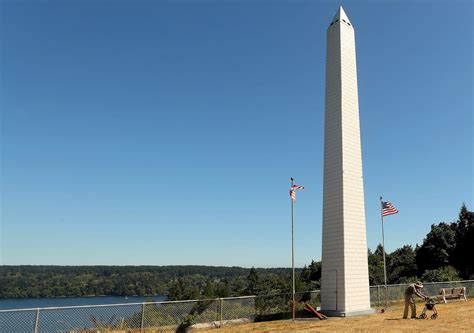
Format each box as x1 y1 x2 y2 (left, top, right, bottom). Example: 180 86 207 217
0 295 166 310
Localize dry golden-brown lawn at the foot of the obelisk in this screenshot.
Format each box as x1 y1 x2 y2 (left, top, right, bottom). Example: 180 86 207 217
193 299 474 333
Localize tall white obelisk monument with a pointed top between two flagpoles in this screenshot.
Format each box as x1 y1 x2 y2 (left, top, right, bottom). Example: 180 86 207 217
321 7 373 316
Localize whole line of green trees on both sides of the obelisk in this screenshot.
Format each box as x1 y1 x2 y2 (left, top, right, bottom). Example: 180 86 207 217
0 205 474 300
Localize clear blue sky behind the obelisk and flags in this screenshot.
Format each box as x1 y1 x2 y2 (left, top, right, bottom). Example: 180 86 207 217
0 0 474 267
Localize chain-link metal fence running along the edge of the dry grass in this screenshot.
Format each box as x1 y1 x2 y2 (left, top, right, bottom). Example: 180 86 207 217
0 280 474 333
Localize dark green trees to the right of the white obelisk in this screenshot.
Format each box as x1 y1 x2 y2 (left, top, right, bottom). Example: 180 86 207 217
368 204 474 285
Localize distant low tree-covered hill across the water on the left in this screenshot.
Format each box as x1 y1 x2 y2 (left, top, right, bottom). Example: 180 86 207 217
0 265 296 298
